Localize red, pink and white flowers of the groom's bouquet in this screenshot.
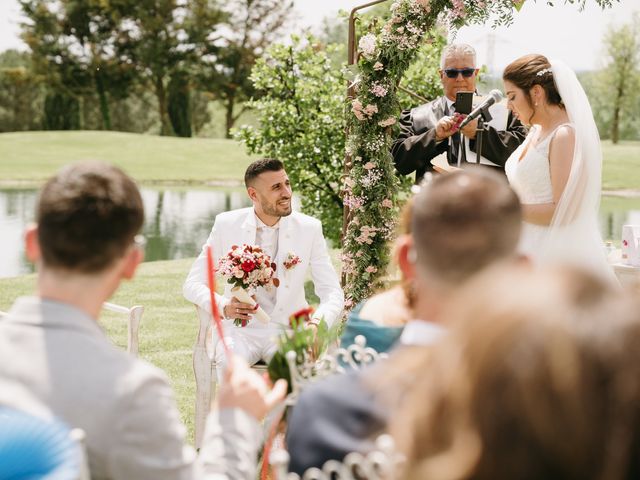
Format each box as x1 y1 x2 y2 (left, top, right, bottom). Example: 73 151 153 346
219 244 279 290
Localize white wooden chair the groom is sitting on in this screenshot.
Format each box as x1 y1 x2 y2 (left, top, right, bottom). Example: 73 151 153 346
193 305 267 449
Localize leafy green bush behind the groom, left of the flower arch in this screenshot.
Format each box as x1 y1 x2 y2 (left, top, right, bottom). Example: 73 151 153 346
236 36 346 244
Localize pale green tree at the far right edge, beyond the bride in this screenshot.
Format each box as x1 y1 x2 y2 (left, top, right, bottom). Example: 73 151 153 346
592 12 640 143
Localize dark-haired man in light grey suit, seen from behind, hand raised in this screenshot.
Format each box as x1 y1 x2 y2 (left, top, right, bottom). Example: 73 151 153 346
0 163 286 480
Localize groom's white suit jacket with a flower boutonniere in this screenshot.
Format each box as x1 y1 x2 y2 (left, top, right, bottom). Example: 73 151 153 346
183 207 344 328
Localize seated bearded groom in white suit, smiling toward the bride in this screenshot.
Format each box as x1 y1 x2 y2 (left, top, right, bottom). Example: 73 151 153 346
183 159 344 364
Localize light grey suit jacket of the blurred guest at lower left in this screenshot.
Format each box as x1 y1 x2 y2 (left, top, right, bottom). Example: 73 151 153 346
0 297 261 480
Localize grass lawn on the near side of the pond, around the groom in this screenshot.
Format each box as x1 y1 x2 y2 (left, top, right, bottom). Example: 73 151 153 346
0 250 339 443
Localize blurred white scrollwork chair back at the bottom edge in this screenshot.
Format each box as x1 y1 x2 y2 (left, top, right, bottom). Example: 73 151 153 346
269 434 404 480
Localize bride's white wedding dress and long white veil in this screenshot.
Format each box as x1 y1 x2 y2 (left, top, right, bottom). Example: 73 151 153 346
505 59 618 284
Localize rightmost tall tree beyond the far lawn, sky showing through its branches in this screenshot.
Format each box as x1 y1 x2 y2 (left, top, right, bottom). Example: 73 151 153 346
195 0 293 138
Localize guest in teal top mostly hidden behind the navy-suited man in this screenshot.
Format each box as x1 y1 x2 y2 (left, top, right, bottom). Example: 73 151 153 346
340 198 414 352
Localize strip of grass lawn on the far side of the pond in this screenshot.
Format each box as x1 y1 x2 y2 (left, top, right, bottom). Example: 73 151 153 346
0 131 252 183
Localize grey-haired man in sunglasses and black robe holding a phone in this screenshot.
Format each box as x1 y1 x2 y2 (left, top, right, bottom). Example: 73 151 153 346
391 44 527 183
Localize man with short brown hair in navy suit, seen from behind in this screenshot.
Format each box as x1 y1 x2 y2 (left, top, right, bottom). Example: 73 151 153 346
287 166 522 474
